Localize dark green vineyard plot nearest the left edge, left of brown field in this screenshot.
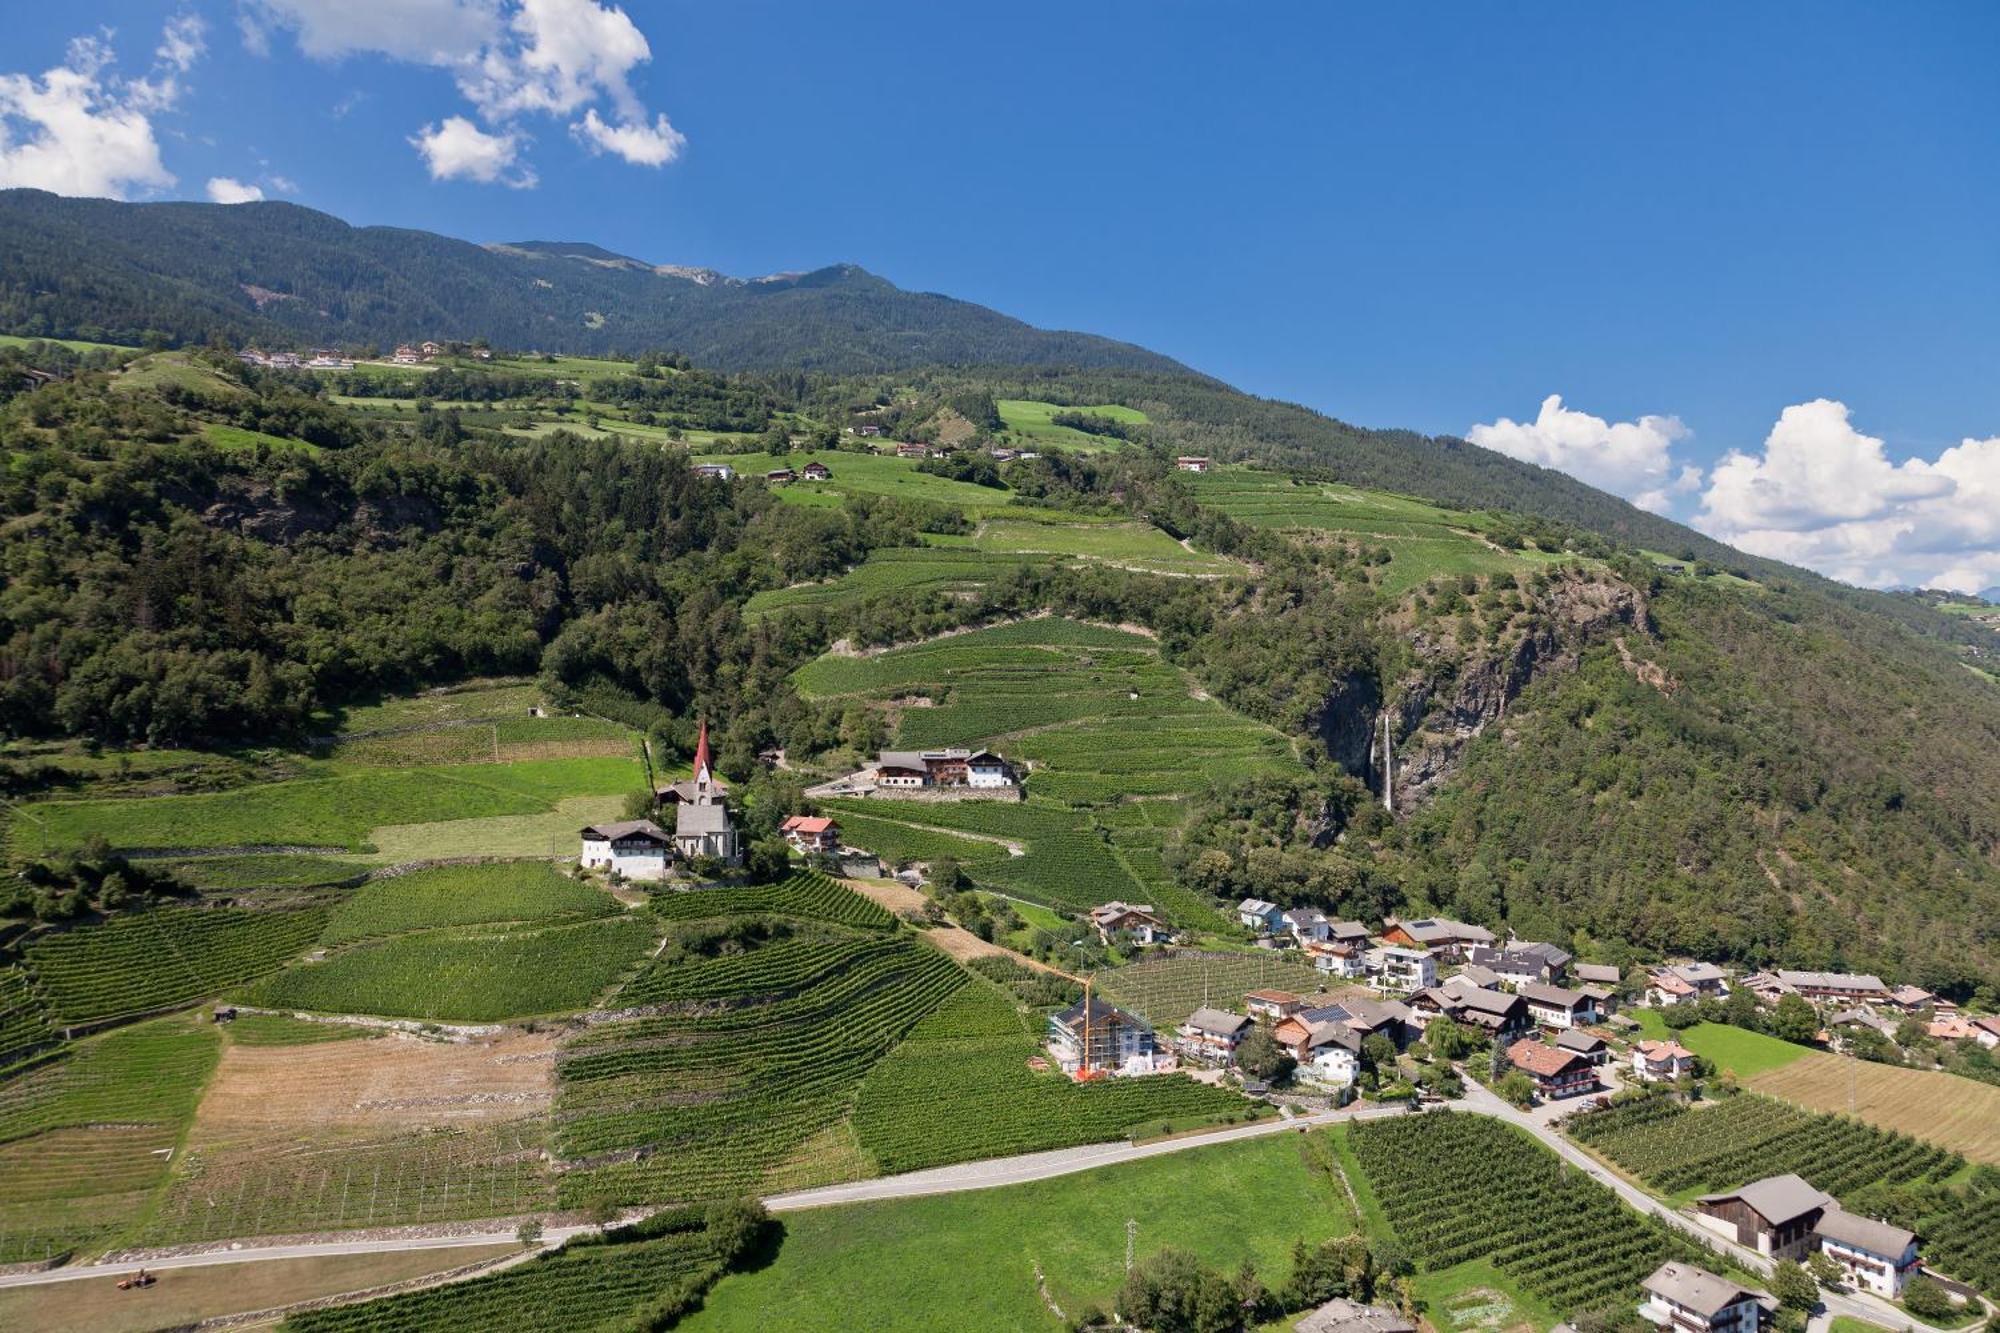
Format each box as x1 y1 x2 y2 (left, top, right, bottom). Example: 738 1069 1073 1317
26 907 326 1023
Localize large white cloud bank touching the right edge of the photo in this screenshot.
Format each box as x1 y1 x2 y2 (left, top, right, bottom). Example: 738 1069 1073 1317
1694 398 2000 592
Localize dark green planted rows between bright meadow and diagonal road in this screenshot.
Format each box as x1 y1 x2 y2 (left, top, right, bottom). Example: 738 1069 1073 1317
1348 1111 1720 1315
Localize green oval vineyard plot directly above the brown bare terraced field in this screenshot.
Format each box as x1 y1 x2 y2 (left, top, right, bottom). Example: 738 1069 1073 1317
242 917 656 1023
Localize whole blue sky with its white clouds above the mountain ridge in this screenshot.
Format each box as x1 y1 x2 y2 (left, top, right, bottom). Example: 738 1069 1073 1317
0 0 2000 586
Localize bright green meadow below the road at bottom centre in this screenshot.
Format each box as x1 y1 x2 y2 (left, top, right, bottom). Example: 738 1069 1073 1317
680 1135 1350 1333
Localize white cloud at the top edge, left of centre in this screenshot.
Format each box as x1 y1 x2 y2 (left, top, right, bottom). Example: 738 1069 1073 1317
250 0 686 186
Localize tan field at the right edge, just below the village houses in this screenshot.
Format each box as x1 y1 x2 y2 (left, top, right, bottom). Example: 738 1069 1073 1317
1750 1051 2000 1165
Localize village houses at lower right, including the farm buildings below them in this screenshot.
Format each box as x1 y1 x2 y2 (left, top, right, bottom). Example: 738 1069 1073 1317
1048 899 1968 1333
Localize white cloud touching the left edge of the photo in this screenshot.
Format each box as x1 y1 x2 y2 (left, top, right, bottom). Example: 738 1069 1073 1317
0 24 177 198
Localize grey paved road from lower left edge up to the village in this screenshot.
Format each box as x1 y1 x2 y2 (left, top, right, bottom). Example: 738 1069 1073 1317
0 1107 1400 1289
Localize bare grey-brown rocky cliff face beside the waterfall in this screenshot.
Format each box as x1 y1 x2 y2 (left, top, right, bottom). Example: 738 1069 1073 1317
1314 574 1652 813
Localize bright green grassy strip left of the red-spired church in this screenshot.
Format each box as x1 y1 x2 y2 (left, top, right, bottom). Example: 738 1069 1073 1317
23 757 644 855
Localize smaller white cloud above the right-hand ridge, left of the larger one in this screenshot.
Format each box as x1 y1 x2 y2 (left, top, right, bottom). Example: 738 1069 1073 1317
1466 394 1702 512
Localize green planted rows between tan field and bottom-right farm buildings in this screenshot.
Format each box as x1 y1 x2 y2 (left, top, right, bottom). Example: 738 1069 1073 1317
1570 1093 1964 1197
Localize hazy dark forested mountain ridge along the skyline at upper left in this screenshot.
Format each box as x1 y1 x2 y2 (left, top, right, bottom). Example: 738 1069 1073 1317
0 190 1184 372
